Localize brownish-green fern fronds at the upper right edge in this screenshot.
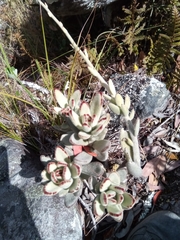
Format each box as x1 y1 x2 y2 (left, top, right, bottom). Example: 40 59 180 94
146 6 180 87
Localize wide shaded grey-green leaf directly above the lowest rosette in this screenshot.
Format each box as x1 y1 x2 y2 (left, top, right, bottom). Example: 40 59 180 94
82 162 106 177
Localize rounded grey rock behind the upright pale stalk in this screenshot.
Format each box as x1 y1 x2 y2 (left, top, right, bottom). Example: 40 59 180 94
111 74 171 119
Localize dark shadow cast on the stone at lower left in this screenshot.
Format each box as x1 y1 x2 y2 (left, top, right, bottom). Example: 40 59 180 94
0 146 41 240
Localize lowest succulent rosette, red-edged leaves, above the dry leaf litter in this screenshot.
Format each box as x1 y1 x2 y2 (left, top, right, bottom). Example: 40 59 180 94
93 173 135 222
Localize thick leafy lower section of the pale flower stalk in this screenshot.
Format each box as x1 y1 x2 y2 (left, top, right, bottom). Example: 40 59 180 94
101 81 142 177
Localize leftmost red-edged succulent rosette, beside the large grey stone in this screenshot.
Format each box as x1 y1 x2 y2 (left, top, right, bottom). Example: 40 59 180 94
41 146 82 197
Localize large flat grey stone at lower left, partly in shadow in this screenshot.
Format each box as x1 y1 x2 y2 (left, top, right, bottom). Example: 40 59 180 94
0 139 82 240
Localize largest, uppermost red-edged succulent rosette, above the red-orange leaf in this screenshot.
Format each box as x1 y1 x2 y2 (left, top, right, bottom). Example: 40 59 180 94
55 89 110 146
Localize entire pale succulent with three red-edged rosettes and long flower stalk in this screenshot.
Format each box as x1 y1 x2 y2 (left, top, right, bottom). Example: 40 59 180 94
35 1 141 225
